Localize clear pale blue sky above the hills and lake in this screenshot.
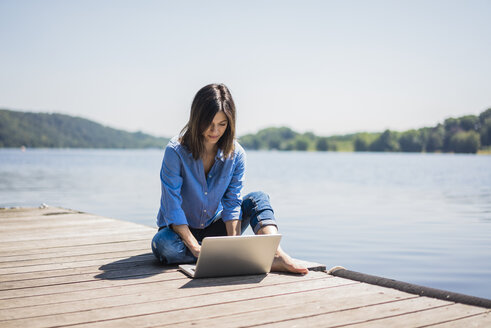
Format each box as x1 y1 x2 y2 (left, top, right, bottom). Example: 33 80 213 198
0 0 491 136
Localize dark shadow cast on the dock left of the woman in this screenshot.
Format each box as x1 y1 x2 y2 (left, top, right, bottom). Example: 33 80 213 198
94 253 177 280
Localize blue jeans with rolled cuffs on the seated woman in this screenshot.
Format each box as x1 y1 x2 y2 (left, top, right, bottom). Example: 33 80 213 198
152 191 276 264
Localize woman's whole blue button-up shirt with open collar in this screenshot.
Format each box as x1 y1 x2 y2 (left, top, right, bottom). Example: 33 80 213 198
157 137 246 229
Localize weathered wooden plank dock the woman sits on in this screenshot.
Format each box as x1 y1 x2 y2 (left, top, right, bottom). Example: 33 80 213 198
0 207 491 328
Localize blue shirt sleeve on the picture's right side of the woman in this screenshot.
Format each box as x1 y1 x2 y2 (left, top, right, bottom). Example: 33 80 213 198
222 150 246 222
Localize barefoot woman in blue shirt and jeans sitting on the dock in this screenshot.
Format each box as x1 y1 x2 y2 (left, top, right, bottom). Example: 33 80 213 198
152 84 308 274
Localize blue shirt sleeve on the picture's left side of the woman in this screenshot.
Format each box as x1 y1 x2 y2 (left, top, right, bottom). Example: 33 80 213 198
160 147 188 226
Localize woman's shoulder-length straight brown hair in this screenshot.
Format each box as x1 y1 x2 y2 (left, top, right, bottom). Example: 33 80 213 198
180 84 235 159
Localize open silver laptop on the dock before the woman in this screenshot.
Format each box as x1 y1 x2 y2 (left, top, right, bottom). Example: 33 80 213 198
179 234 281 278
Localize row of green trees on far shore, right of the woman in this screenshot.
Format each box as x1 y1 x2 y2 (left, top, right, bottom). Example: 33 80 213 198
240 108 491 153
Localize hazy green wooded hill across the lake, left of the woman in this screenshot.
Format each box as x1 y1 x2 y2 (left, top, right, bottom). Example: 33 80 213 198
0 109 168 148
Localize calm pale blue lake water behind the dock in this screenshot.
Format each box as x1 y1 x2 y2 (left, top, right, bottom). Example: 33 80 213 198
0 149 491 298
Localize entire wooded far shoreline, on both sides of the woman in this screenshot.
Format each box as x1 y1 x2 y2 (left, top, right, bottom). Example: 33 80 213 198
0 108 491 153
